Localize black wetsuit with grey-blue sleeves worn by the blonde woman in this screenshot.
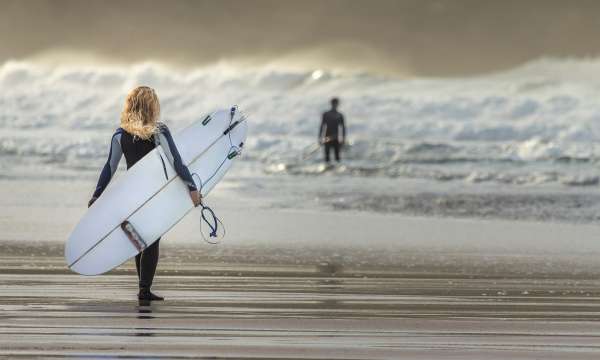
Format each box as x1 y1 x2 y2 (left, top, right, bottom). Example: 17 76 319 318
94 124 196 289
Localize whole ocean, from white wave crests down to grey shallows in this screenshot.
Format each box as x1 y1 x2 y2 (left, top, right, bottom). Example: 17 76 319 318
0 58 600 223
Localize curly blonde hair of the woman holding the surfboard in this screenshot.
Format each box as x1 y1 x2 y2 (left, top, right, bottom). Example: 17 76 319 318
121 86 160 140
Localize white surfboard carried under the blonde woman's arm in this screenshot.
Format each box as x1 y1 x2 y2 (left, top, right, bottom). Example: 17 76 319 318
65 108 247 275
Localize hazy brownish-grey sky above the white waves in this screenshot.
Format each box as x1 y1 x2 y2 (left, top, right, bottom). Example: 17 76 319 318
0 0 600 76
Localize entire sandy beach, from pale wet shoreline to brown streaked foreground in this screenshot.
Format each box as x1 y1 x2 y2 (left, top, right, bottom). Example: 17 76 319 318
0 181 600 359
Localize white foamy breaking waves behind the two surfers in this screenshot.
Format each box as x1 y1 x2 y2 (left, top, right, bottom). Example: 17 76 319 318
0 59 600 187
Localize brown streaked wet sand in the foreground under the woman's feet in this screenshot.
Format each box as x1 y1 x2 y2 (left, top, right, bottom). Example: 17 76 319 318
0 245 600 359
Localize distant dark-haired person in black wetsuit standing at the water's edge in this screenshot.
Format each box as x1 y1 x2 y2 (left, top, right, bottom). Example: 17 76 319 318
319 98 346 162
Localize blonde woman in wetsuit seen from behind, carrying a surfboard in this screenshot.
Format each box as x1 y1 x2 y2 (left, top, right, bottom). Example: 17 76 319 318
88 86 201 301
